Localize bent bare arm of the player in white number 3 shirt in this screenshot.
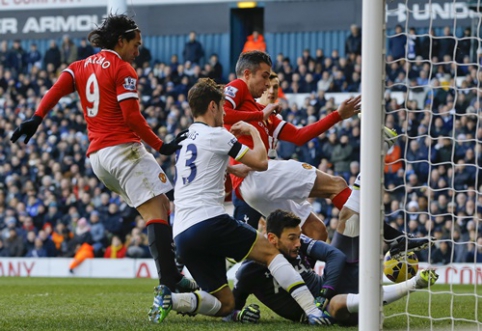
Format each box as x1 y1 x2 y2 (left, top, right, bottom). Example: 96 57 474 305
230 121 268 171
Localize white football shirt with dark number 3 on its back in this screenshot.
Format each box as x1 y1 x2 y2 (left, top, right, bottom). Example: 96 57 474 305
173 122 249 237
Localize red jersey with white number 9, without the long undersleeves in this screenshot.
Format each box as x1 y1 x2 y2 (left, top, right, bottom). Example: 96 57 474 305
65 50 146 155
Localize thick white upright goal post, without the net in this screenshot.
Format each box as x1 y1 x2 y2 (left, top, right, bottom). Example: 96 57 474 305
359 0 385 330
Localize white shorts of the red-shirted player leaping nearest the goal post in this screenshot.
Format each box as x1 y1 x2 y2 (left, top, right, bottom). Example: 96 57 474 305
240 160 316 225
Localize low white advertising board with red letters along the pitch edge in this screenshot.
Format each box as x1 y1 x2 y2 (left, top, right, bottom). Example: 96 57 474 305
0 258 482 285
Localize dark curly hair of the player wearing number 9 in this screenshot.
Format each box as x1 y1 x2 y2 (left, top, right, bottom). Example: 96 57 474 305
87 14 141 49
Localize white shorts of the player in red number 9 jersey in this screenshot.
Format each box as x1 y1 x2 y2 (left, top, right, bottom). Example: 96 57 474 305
90 143 172 208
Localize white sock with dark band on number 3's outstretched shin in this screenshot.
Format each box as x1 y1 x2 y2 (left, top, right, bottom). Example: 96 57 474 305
268 254 321 316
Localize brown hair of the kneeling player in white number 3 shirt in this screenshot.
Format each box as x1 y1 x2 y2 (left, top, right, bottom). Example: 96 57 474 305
187 78 224 117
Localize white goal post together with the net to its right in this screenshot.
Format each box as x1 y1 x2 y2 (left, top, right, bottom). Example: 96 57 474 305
359 0 482 331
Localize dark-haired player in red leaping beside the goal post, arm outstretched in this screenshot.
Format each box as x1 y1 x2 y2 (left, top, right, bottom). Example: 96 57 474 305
224 51 361 240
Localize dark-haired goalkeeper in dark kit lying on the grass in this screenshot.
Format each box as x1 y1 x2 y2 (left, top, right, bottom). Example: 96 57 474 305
233 209 438 325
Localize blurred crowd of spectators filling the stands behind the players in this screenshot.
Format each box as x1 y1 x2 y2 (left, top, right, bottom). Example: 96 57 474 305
0 26 482 264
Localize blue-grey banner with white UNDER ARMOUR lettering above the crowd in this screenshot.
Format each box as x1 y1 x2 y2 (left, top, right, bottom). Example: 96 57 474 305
0 0 479 40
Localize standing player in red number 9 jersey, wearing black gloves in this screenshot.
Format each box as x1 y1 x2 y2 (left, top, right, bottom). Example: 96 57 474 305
11 15 197 291
